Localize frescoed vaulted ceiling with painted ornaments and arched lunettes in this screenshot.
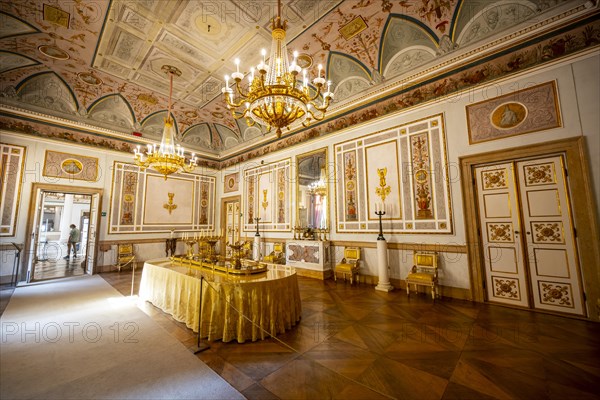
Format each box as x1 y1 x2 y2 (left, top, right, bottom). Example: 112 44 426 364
0 0 592 159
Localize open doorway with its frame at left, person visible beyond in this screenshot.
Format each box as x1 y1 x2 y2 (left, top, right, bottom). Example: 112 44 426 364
19 183 102 282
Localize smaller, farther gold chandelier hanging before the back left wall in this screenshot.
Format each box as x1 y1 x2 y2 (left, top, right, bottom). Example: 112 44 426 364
133 65 197 180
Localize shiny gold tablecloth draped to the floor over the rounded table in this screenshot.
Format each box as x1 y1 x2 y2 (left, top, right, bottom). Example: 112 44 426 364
139 260 301 343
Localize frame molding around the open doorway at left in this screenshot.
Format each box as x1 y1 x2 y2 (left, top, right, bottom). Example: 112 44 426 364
22 182 104 281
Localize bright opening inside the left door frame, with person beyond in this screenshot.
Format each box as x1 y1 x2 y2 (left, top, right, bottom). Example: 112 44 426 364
32 191 92 281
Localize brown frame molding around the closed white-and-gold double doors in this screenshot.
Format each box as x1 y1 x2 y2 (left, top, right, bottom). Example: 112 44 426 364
459 136 600 321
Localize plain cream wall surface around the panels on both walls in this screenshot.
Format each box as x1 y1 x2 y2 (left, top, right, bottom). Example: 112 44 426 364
0 51 600 288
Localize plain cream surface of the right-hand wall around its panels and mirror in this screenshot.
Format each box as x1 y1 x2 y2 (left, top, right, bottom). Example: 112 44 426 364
217 51 600 289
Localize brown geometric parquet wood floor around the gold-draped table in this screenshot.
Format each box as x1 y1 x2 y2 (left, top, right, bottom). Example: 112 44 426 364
102 270 600 399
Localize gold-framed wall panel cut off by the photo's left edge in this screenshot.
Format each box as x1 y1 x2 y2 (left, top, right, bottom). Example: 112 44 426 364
0 143 27 237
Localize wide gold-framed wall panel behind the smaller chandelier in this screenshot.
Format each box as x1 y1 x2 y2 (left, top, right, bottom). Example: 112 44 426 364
108 161 216 234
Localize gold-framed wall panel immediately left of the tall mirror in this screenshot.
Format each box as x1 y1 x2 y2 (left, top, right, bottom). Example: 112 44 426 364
242 158 295 232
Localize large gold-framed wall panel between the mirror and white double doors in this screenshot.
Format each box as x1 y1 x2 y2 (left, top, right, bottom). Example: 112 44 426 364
334 114 453 233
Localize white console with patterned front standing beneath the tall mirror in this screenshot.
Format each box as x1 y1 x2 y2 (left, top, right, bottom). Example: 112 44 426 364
285 240 332 279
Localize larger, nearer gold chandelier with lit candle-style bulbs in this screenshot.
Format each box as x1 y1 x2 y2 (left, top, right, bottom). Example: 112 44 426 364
222 0 333 137
